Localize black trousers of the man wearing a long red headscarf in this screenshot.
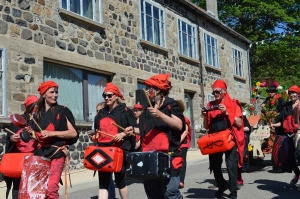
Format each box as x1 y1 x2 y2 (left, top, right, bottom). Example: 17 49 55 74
209 145 239 196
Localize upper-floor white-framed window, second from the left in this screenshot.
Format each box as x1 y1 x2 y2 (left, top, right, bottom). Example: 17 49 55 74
141 0 165 47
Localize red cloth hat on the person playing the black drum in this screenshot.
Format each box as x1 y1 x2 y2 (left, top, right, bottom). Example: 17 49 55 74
144 74 170 91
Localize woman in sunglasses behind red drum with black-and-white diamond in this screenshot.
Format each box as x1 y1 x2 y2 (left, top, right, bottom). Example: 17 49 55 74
93 82 136 199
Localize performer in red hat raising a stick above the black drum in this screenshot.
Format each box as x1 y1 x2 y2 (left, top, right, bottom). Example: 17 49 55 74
142 74 185 199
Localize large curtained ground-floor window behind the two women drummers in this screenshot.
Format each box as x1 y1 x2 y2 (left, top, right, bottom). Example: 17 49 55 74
44 62 108 121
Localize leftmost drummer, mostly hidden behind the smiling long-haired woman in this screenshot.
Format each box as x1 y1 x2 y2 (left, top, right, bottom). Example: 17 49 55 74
3 95 38 199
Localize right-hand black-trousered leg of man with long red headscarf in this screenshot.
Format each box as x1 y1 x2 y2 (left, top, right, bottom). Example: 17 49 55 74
225 145 239 197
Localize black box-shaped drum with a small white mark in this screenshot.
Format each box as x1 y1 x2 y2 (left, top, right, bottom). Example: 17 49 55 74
126 151 171 179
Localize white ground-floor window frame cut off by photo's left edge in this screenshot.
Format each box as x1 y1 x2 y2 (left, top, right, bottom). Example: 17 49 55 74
0 45 7 117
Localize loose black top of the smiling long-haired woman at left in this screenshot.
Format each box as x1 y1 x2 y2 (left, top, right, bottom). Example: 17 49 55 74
33 105 78 158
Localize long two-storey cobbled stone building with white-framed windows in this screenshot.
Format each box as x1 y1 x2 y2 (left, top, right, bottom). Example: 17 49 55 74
0 0 250 168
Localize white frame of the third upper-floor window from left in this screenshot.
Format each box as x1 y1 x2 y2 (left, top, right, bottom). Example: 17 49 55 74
177 17 199 60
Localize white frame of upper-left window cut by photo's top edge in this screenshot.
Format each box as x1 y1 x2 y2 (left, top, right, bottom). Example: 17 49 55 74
59 0 103 23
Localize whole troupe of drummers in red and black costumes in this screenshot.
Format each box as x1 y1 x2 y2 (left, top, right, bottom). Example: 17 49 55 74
4 74 300 199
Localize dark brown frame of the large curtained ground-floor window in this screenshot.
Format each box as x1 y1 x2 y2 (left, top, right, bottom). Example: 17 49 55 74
43 61 112 122
